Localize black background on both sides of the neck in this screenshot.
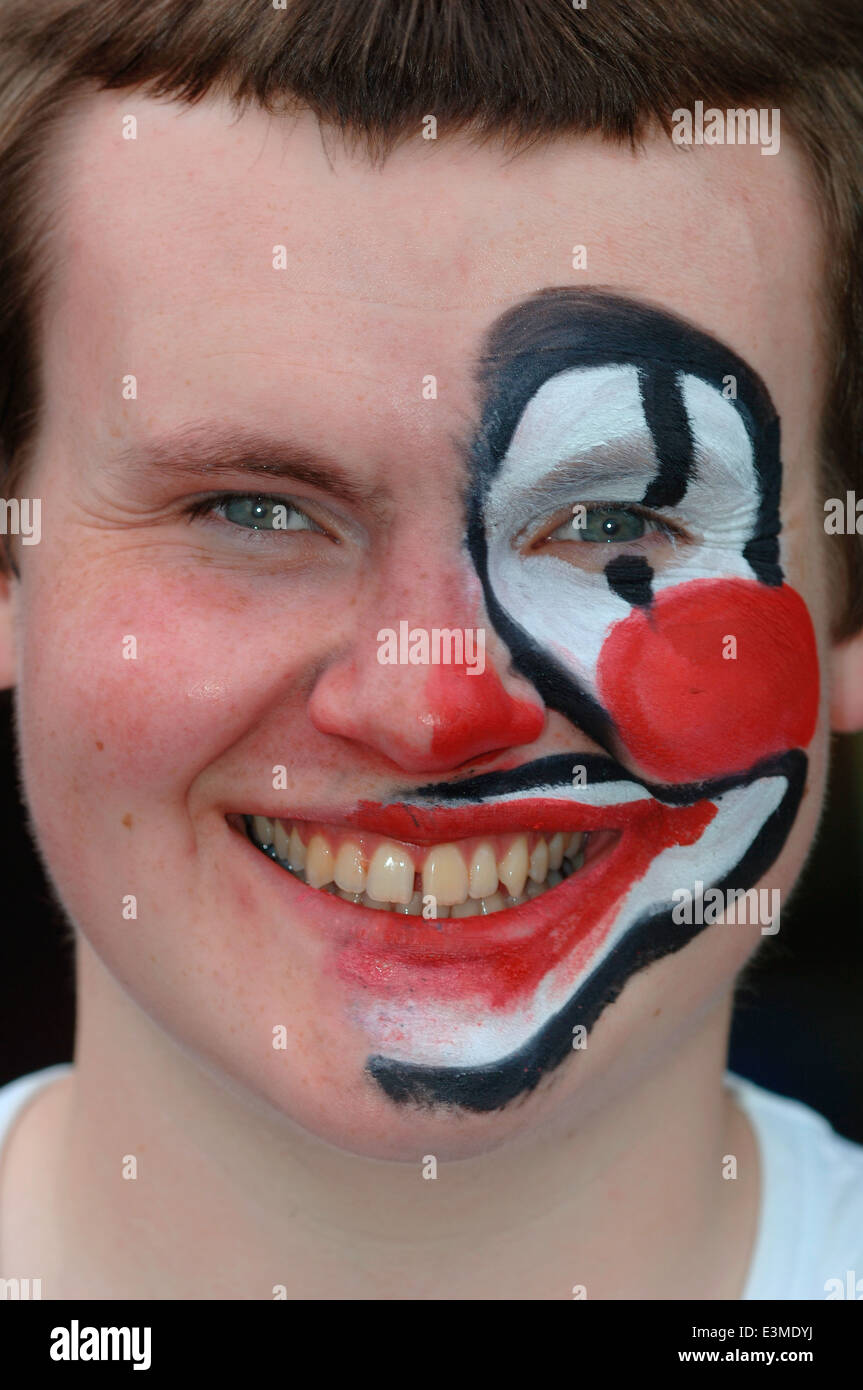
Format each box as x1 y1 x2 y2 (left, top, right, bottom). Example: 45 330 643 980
0 694 863 1143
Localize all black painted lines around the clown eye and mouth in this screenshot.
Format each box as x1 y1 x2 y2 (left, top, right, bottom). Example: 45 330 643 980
365 289 807 1112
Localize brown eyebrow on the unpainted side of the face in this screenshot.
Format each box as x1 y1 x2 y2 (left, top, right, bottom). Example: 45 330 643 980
115 424 386 512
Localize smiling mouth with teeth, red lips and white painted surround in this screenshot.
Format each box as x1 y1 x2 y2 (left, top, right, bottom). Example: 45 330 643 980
225 778 802 1089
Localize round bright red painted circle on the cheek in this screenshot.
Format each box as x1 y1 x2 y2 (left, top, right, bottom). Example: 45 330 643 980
598 580 819 783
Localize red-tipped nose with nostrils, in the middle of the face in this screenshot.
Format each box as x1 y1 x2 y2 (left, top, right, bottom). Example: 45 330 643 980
309 628 545 774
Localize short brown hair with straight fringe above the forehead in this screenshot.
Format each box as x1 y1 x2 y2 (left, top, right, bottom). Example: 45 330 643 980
0 0 863 638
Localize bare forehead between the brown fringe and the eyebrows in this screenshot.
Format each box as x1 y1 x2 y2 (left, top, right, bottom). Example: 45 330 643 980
38 93 821 472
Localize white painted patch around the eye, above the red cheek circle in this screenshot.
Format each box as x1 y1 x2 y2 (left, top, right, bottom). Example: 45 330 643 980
485 366 757 698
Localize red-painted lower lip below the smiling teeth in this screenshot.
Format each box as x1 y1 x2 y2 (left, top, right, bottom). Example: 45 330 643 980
226 801 716 1008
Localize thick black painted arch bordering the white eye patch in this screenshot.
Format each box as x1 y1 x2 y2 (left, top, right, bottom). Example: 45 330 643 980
466 289 782 752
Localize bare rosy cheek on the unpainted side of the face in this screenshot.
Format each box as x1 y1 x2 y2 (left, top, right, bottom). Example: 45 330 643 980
19 563 308 858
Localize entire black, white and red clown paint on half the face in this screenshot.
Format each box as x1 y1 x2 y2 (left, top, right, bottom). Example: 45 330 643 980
332 291 819 1111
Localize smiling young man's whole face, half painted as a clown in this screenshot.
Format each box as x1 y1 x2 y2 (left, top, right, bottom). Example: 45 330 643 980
5 93 828 1159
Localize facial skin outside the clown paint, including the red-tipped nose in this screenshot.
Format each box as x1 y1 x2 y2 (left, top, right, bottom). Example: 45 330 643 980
5 93 827 1159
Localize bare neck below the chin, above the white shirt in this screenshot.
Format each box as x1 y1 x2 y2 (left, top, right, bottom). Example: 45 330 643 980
45 941 756 1300
